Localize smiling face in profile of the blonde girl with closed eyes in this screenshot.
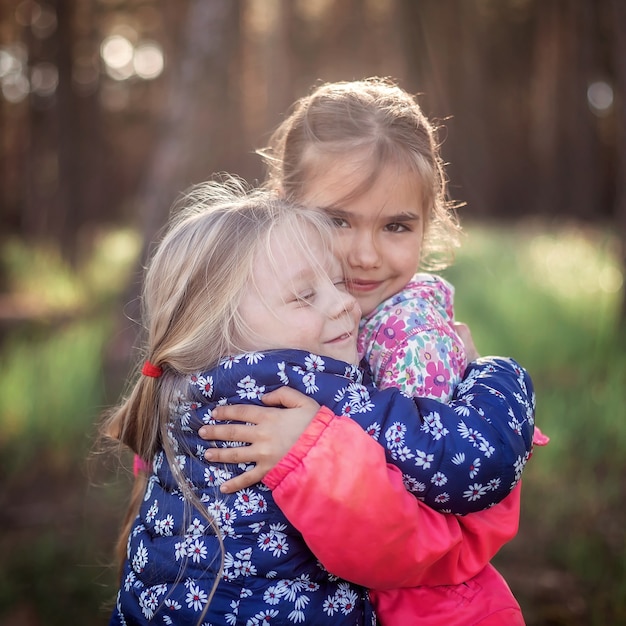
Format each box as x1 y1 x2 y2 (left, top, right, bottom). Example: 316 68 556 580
239 224 361 365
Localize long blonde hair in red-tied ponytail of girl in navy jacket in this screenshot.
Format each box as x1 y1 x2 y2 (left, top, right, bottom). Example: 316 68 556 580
102 176 332 606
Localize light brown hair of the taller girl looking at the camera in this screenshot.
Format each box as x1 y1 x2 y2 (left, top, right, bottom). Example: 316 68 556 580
258 77 460 269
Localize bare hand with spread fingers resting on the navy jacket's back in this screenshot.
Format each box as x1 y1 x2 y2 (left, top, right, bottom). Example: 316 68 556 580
198 387 320 493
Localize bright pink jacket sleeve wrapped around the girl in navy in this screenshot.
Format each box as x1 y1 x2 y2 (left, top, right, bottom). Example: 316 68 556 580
263 407 520 589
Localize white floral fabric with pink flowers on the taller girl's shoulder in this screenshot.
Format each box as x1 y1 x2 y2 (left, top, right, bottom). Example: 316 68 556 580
359 274 467 402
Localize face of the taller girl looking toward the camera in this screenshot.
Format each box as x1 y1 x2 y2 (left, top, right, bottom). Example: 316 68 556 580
300 158 425 315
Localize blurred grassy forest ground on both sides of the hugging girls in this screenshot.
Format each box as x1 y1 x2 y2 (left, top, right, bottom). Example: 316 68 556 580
0 225 626 626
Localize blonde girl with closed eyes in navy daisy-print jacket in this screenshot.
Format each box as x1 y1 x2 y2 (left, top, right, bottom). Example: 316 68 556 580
104 176 532 624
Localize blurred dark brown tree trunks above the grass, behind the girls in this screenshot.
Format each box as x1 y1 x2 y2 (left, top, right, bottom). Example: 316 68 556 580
0 0 626 310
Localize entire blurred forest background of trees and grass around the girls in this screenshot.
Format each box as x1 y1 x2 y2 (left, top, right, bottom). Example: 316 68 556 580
0 0 626 626
